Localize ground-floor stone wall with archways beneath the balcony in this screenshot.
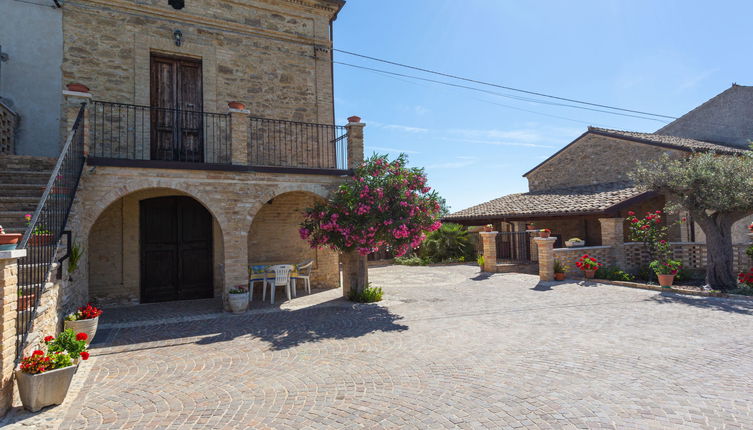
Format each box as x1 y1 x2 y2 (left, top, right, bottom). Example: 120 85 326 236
69 166 343 301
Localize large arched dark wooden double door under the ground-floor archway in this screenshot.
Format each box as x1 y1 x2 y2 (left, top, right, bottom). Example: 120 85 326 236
140 196 214 303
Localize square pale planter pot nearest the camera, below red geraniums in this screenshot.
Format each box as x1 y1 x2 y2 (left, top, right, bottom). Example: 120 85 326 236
16 365 78 412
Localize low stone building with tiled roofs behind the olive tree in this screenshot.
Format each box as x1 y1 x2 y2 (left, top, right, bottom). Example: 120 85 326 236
444 84 753 248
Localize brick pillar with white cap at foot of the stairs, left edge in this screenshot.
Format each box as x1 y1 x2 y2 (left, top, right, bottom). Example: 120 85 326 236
0 249 26 417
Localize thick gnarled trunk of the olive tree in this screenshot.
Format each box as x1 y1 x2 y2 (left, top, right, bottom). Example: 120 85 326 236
694 214 737 291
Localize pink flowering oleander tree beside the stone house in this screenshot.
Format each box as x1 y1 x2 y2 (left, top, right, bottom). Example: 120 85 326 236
300 154 441 292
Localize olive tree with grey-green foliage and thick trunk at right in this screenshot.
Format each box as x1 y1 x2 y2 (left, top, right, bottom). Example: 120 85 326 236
631 151 753 291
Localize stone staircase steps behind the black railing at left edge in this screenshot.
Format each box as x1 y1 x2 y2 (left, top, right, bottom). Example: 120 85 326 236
0 155 56 233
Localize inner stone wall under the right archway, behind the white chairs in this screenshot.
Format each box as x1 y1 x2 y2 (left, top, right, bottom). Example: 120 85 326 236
248 191 339 288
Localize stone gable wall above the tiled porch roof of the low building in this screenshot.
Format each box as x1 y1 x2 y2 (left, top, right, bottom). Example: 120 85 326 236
526 134 687 191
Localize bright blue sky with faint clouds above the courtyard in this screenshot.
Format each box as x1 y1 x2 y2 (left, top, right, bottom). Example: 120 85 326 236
335 0 753 210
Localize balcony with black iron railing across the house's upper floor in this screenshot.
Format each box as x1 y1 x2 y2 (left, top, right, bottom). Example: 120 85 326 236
88 101 350 175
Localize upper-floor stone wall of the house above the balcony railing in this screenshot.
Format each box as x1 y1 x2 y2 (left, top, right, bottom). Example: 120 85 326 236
63 0 336 123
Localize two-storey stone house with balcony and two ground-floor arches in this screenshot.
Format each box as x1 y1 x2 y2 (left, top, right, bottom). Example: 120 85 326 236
0 0 364 404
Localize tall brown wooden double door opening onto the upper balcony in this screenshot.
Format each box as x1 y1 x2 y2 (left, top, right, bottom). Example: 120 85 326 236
150 54 204 163
